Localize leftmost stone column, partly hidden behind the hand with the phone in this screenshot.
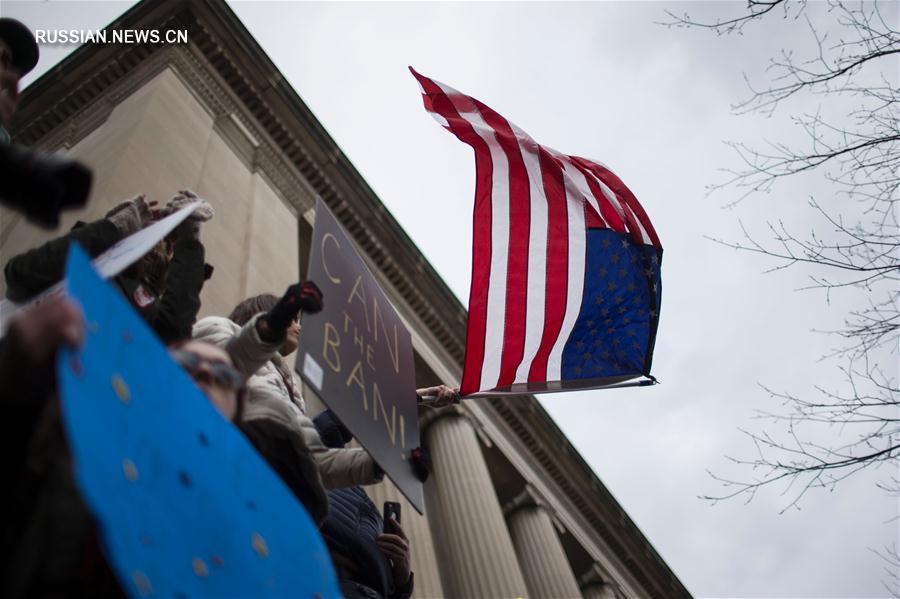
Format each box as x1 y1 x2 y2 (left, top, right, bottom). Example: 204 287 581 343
363 478 446 599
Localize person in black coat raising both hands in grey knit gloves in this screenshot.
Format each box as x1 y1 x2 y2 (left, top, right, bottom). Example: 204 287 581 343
3 190 214 344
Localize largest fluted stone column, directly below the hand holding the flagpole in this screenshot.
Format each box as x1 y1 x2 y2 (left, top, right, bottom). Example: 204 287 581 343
425 408 527 599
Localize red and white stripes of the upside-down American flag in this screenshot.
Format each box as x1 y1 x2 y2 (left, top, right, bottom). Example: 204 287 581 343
410 68 659 395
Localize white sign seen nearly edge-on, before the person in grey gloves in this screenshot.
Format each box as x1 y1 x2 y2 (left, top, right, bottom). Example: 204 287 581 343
0 202 200 335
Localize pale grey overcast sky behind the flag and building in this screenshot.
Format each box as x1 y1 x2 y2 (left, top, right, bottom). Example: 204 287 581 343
3 2 898 597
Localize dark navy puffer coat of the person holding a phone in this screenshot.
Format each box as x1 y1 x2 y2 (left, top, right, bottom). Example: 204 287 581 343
314 410 413 599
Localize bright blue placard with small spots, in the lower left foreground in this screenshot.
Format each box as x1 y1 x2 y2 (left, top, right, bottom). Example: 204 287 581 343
57 243 340 597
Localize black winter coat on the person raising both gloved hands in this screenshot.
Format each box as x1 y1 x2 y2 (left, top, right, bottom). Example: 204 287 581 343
3 219 207 344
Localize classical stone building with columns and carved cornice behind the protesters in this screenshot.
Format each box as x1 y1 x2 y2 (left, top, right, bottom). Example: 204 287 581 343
0 0 690 599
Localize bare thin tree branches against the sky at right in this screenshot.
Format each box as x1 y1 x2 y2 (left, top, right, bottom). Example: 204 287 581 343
680 0 900 520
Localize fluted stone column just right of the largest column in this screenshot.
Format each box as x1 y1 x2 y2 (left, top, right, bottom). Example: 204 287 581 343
507 491 581 599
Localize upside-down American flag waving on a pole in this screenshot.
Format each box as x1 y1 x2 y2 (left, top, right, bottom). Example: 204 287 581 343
410 67 662 395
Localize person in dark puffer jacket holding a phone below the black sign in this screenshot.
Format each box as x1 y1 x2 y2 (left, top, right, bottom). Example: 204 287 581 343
313 410 413 599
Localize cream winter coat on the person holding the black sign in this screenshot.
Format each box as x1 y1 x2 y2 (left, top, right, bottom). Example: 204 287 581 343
194 314 384 488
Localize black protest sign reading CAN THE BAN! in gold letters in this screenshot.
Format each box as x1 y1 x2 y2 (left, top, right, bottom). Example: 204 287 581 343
295 200 424 513
